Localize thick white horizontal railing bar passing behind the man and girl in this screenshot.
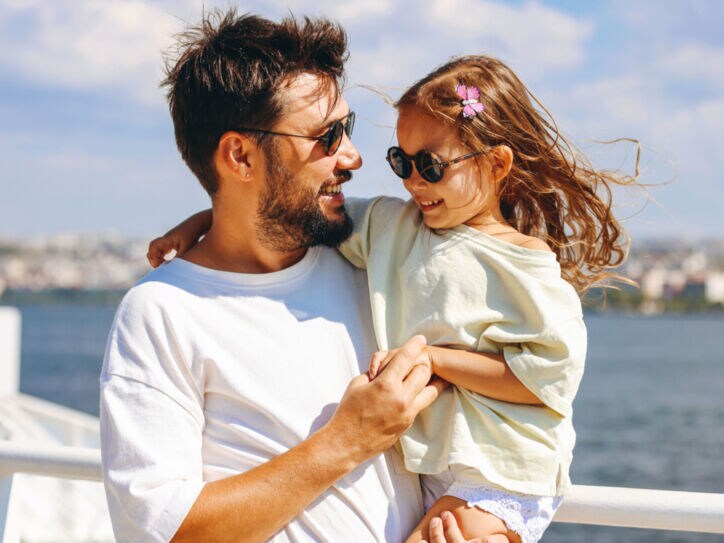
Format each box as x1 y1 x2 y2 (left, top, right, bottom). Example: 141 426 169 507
0 441 724 534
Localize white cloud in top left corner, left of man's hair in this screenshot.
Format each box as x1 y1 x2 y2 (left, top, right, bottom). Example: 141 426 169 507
0 0 181 104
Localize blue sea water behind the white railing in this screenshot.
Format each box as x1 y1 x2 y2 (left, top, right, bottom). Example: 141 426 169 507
9 305 724 543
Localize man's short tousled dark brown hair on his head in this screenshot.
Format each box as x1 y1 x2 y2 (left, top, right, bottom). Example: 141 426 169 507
161 9 347 194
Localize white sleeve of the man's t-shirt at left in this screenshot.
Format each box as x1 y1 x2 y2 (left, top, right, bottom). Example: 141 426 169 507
100 296 204 542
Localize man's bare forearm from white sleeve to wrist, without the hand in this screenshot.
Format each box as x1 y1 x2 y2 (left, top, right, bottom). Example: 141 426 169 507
172 428 358 543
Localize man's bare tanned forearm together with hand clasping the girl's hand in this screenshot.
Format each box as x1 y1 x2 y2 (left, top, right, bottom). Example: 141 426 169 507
173 336 444 543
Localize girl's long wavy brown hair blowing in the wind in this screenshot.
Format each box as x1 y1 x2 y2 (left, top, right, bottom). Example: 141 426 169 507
395 56 638 291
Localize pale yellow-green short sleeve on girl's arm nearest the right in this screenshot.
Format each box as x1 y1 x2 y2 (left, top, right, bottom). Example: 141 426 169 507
481 280 587 417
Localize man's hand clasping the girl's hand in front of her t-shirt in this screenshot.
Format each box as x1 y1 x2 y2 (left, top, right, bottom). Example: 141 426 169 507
324 336 447 465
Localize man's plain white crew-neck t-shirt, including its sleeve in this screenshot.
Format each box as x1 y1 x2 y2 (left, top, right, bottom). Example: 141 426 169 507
101 248 422 543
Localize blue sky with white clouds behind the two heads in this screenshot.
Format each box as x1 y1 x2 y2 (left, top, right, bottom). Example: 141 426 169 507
0 0 724 242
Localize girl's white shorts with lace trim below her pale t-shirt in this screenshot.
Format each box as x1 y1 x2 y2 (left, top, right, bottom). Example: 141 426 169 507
421 466 563 543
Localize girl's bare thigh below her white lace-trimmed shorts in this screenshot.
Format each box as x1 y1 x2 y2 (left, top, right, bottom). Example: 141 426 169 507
406 496 521 543
